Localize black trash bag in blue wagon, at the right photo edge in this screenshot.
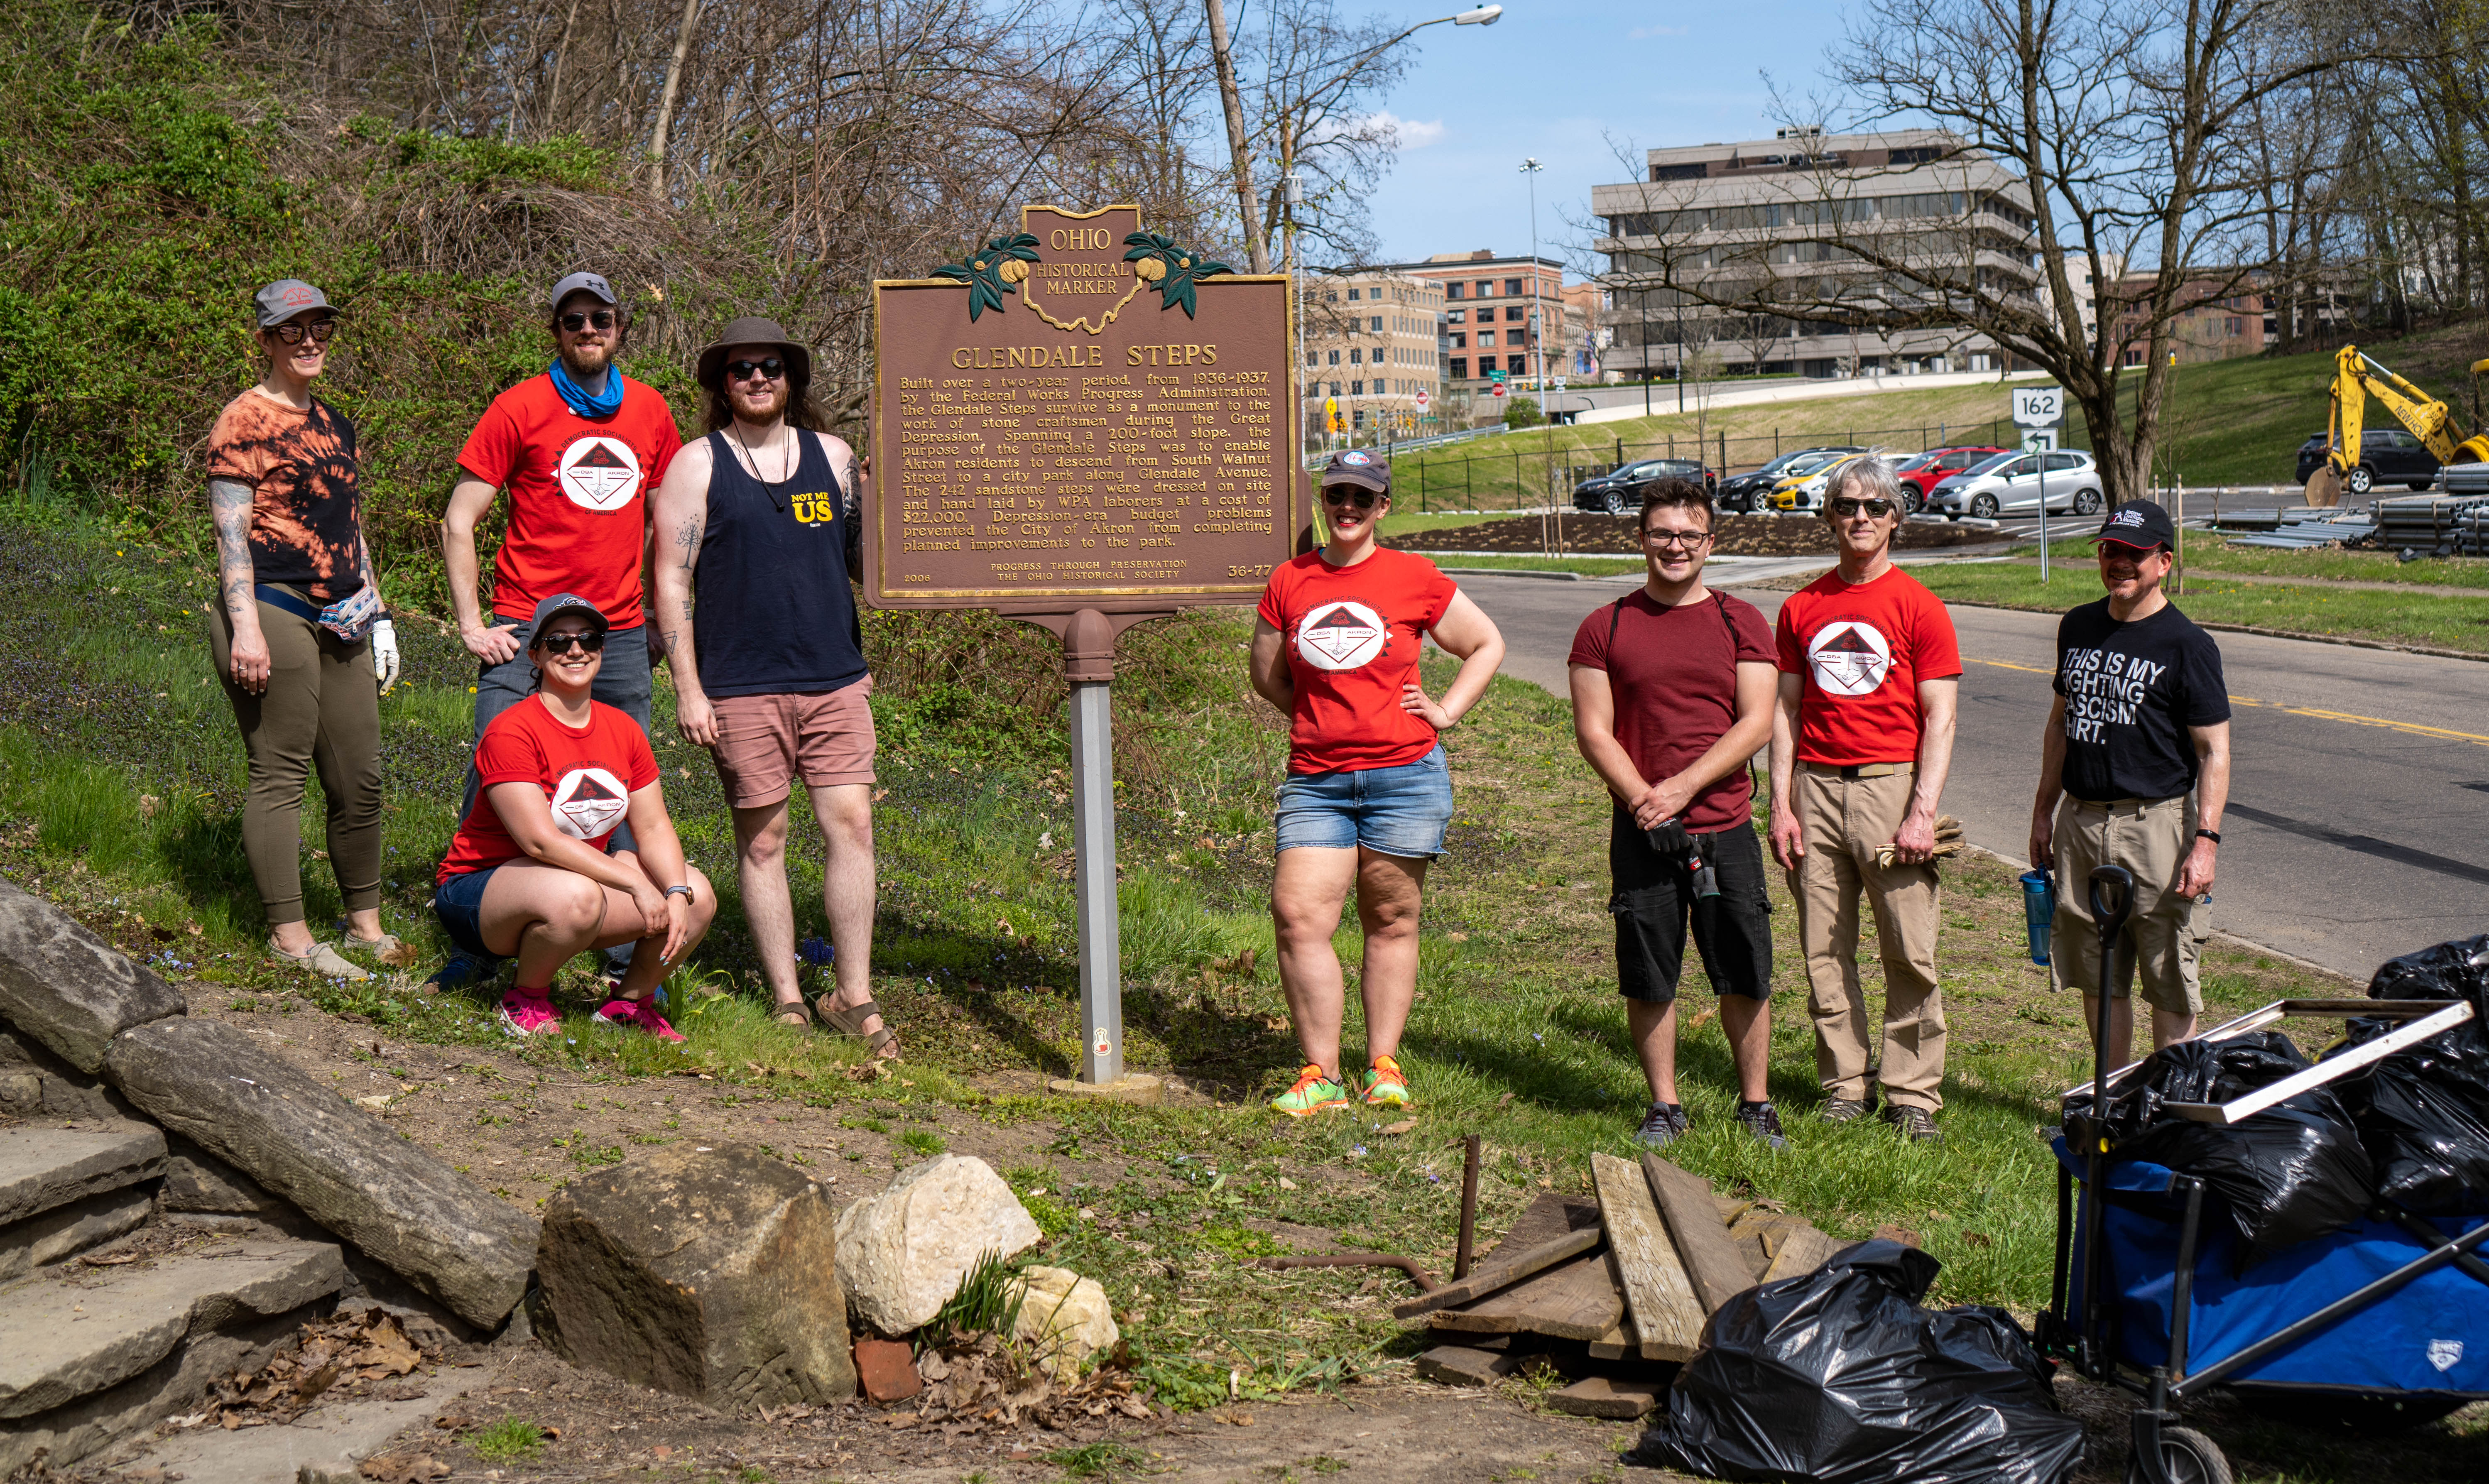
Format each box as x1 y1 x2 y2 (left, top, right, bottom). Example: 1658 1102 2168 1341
2337 936 2489 1215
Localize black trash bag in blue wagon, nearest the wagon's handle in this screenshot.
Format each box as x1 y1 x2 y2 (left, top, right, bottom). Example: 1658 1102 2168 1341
2066 1031 2374 1267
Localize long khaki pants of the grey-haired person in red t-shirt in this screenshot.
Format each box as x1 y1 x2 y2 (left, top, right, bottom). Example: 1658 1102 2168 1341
1790 762 1944 1111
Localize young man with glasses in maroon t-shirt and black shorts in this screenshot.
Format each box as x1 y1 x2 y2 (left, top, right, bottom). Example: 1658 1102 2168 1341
1570 478 1787 1148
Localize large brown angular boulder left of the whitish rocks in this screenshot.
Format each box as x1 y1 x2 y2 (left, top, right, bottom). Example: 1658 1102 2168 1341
535 1143 856 1407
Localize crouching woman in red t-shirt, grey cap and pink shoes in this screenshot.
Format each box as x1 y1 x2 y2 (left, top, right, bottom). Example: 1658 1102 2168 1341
433 593 717 1041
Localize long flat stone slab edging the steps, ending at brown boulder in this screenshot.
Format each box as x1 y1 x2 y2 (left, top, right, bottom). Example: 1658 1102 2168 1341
105 1016 538 1330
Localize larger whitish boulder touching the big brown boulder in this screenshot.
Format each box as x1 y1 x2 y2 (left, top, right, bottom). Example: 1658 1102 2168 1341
839 1155 1045 1335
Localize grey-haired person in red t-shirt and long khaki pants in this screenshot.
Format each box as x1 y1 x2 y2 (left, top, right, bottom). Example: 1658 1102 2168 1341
1772 453 1961 1143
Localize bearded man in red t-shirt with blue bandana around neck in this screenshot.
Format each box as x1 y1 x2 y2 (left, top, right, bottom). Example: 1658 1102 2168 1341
438 274 682 989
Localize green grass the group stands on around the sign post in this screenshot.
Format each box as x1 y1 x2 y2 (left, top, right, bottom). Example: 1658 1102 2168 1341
0 508 2489 1479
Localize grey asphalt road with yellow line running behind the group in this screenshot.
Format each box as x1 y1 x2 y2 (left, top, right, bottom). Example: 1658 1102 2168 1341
1458 578 2489 979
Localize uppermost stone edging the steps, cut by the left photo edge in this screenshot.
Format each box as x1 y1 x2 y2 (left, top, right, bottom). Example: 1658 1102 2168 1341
0 882 189 1073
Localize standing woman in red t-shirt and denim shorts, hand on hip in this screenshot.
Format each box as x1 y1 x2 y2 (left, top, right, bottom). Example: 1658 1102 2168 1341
1252 448 1503 1118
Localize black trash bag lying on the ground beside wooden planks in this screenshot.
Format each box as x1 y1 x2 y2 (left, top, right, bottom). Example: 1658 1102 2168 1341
1625 1240 2083 1484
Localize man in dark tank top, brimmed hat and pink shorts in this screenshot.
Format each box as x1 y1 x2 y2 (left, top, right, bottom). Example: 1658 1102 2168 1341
654 319 899 1058
